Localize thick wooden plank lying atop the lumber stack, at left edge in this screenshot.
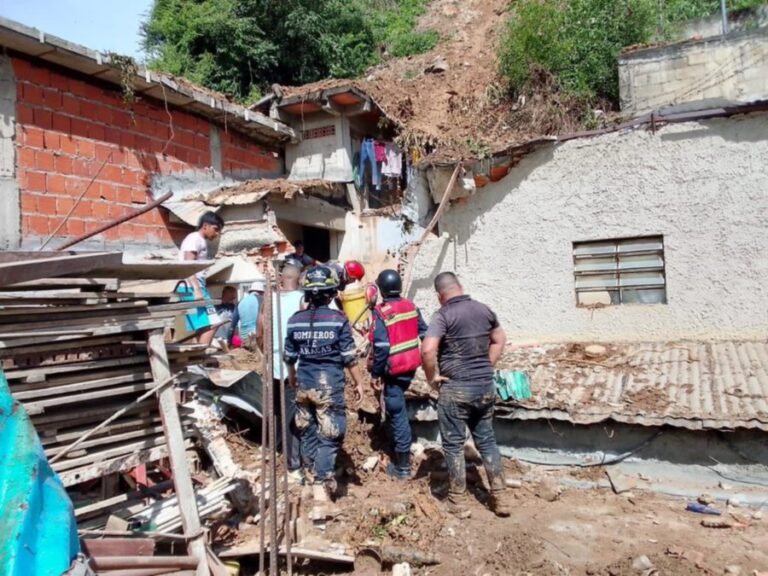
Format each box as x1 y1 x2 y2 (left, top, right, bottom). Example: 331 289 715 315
0 252 123 286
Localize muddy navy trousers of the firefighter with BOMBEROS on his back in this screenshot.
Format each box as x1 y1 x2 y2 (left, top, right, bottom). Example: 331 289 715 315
296 382 347 482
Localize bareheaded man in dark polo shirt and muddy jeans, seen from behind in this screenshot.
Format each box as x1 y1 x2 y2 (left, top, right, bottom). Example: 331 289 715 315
421 272 512 516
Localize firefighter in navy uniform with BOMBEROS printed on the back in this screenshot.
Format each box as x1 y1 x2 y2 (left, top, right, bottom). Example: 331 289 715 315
284 266 363 502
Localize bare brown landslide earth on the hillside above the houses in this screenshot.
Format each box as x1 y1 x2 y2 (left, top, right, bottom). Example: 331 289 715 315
283 0 583 158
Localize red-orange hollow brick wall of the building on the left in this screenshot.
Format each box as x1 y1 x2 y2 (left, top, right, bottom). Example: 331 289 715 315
13 58 280 247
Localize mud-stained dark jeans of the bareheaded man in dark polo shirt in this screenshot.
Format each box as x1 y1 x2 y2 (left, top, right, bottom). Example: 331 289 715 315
437 381 505 494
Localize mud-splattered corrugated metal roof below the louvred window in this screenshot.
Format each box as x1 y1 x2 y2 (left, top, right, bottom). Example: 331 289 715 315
498 341 768 430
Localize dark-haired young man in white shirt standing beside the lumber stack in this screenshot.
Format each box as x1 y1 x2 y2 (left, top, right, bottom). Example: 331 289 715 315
179 212 224 344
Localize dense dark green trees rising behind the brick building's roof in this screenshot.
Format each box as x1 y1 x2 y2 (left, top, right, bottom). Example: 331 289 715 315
142 0 438 102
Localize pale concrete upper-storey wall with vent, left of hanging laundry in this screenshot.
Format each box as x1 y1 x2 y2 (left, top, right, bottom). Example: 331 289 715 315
285 113 352 182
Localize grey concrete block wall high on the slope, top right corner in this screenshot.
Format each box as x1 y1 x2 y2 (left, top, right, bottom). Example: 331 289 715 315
619 28 768 114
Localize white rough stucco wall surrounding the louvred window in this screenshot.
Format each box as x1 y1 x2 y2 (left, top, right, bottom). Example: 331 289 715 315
411 115 768 341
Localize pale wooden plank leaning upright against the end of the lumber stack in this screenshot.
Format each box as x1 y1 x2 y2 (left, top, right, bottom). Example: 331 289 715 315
147 330 210 576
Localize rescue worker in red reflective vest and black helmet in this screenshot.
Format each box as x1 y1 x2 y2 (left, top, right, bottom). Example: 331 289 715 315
368 270 427 480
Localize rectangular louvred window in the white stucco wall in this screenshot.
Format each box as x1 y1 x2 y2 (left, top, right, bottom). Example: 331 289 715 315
573 236 667 306
